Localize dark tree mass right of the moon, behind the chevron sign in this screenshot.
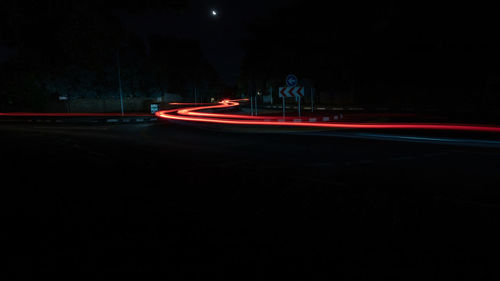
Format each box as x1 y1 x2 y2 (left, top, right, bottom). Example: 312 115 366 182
239 1 500 111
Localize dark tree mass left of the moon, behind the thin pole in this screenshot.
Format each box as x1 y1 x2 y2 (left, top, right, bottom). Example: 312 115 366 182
0 0 220 110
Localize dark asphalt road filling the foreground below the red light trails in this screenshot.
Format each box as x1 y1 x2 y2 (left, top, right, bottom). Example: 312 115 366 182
0 122 500 280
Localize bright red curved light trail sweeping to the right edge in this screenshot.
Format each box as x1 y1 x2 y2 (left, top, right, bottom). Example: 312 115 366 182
156 100 500 133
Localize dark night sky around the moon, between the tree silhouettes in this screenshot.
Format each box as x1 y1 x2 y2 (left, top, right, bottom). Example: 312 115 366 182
122 0 291 84
